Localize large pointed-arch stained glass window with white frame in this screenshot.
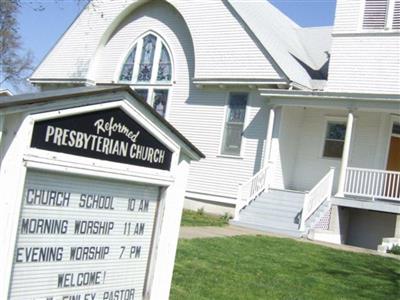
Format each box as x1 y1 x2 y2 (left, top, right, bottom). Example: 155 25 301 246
119 32 172 117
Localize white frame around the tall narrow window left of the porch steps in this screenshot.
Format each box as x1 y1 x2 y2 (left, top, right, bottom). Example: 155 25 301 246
217 90 251 159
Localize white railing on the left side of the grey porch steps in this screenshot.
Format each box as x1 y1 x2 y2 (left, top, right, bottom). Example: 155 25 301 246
234 164 272 220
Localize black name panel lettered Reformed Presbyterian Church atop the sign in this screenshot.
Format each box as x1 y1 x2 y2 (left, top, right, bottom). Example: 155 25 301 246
31 108 172 170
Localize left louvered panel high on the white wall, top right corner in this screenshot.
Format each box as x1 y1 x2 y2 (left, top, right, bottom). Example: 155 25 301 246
363 0 389 29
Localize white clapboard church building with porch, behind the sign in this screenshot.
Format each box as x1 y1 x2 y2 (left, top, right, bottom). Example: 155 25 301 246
30 0 400 250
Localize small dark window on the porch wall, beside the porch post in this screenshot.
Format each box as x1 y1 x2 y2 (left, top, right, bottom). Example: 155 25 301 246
323 121 346 158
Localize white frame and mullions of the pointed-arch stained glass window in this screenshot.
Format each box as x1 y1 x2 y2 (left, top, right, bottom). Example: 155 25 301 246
114 30 175 119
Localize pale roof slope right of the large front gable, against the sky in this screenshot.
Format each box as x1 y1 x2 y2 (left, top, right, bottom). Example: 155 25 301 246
229 0 332 87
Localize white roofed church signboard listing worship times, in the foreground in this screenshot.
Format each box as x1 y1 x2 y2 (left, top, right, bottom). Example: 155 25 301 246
0 89 202 300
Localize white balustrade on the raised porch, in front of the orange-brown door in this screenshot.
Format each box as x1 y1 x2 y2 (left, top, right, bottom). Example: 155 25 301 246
344 168 400 201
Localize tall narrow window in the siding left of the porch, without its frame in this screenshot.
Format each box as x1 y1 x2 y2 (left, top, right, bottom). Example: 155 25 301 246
221 93 248 156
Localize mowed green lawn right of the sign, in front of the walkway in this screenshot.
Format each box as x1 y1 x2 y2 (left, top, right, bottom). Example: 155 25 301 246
170 236 400 300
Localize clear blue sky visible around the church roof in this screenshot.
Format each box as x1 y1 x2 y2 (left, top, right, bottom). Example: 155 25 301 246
1 0 336 92
